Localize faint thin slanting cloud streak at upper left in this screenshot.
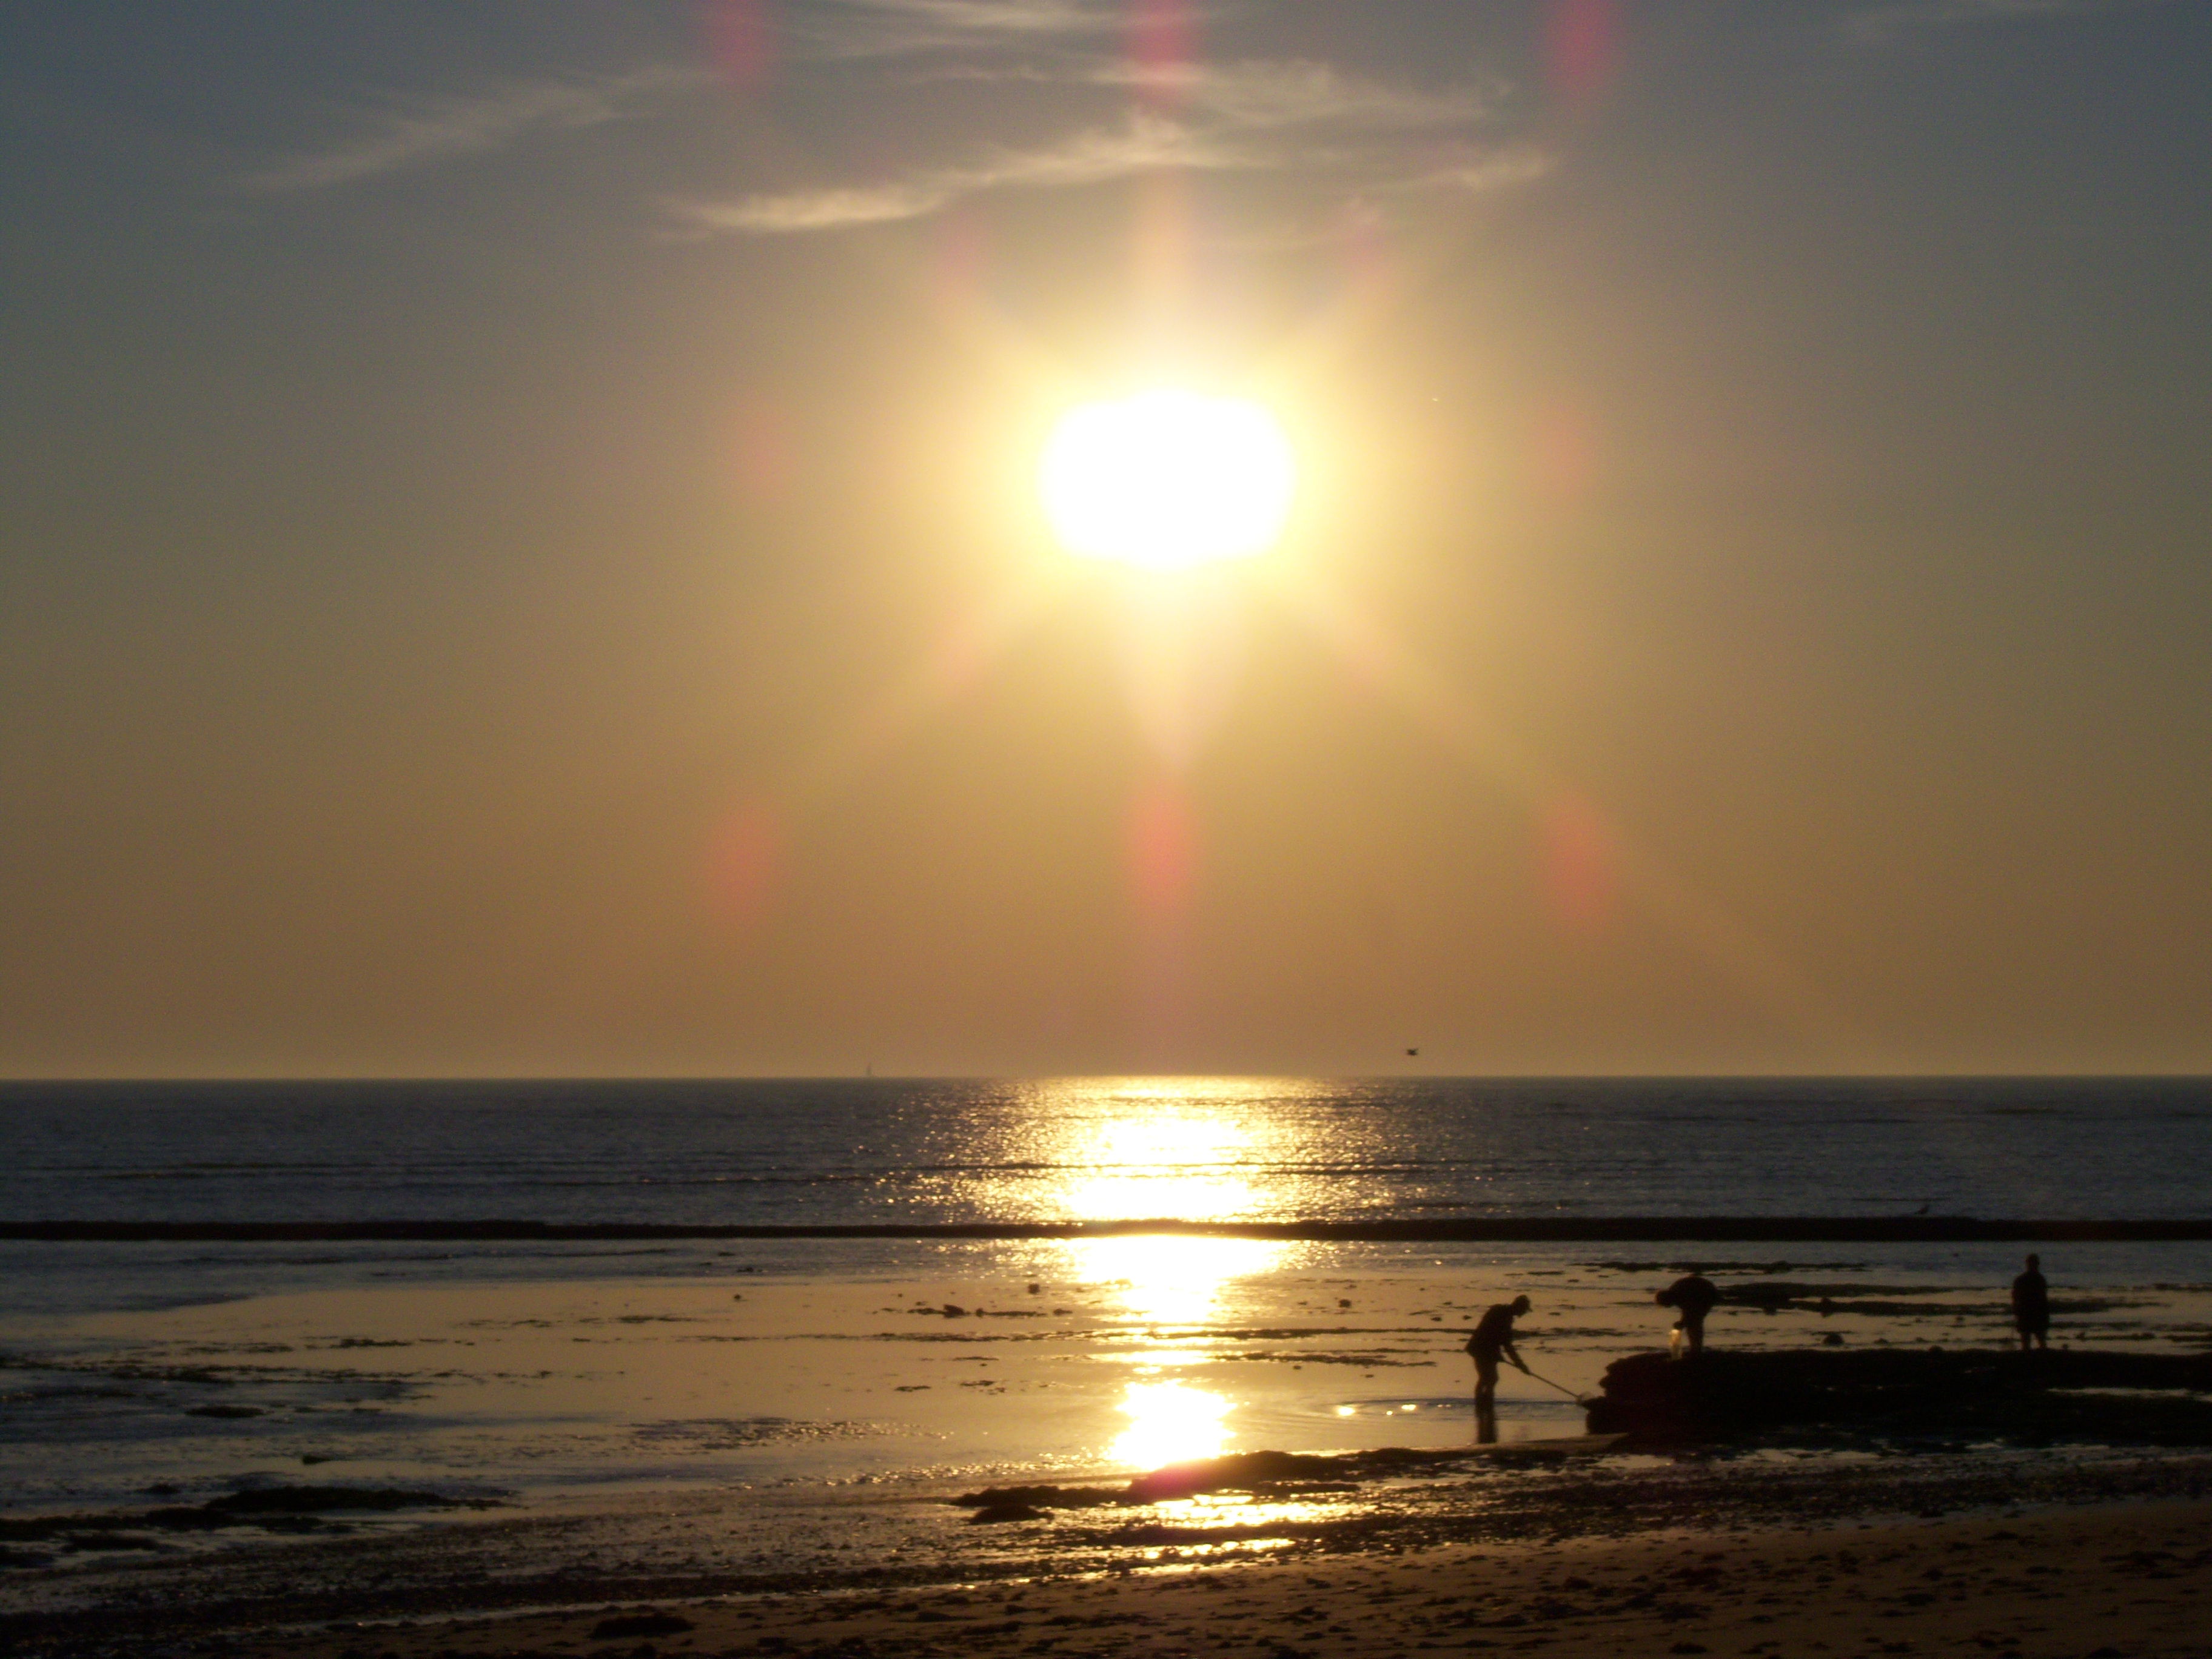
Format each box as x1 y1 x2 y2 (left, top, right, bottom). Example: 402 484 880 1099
235 64 701 195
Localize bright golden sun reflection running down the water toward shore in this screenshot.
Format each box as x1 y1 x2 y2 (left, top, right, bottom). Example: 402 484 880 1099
995 1079 1336 1469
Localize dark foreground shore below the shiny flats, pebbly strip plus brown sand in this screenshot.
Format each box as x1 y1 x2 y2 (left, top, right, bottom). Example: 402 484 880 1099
13 1449 2212 1659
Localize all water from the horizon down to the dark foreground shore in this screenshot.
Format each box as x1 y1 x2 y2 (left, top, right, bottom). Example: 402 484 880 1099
0 1078 2212 1549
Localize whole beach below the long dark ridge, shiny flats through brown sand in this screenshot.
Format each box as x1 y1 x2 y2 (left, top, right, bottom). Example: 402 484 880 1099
13 1239 2212 1659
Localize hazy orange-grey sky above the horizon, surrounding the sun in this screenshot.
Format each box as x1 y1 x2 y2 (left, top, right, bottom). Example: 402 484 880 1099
0 0 2212 1078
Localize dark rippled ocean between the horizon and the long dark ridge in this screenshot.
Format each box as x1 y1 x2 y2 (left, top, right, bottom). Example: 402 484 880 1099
0 1078 2212 1223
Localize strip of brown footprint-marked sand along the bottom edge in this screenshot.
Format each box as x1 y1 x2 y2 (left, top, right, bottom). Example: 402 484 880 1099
13 1500 2212 1659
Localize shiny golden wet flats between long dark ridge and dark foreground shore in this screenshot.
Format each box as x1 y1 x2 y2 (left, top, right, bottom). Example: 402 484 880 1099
0 1236 2212 1513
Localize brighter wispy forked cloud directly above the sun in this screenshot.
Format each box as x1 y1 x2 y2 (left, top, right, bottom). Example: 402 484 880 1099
672 59 1550 235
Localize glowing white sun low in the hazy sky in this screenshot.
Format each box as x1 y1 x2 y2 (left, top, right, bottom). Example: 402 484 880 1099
1037 389 1298 571
